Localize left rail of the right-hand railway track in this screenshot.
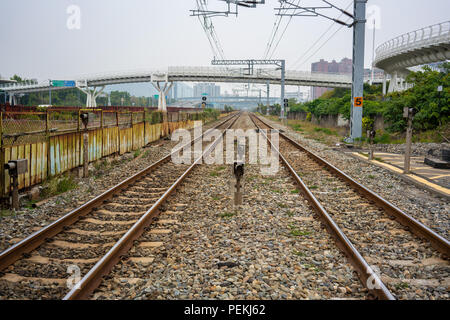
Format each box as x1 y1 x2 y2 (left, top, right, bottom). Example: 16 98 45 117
250 115 395 300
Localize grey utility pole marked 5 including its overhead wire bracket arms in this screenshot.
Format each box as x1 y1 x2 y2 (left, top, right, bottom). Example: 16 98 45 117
275 0 367 142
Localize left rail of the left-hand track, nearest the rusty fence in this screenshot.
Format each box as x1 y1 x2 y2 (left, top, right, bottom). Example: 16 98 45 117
0 113 239 271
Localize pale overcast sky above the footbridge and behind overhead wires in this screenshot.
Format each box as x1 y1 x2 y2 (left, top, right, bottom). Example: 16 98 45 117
0 0 450 92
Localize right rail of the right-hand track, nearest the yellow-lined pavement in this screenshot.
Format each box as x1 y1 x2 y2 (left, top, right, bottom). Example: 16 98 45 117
253 114 450 259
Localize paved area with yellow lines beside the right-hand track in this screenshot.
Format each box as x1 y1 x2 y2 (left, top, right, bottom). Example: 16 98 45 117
352 152 450 197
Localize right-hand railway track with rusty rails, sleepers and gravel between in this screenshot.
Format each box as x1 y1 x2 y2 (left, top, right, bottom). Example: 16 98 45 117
251 115 450 300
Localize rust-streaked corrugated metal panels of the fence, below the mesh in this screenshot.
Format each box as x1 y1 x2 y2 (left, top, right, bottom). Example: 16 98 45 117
0 112 194 196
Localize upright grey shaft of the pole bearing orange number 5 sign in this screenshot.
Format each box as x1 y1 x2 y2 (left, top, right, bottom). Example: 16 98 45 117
350 0 367 142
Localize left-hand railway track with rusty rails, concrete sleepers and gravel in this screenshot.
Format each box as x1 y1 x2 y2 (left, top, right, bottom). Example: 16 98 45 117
0 114 243 299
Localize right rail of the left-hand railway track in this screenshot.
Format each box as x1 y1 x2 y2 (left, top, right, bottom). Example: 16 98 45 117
64 113 240 300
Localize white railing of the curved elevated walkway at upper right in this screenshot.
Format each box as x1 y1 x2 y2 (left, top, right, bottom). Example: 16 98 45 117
375 21 450 62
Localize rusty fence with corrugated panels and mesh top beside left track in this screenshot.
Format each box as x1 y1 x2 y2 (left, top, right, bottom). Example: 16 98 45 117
0 109 206 197
